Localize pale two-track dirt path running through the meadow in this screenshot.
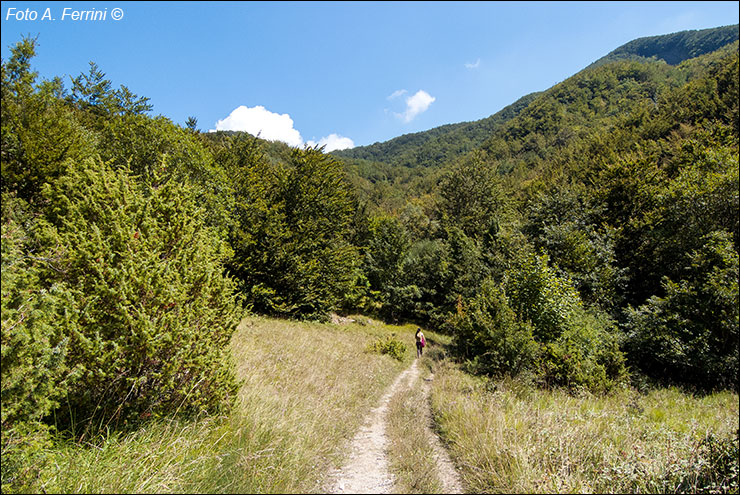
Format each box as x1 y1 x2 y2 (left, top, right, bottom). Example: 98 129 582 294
328 360 462 493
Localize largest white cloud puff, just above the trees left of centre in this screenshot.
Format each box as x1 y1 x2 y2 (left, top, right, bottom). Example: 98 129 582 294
215 105 303 147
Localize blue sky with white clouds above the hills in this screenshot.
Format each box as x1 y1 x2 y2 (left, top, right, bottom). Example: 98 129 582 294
1 1 738 150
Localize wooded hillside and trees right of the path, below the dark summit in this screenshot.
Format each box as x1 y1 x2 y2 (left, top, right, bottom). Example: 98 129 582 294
336 27 738 387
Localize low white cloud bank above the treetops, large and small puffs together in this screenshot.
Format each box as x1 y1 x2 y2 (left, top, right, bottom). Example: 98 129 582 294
211 105 355 153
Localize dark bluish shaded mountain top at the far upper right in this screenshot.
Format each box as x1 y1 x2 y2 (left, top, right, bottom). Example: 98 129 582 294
590 24 738 67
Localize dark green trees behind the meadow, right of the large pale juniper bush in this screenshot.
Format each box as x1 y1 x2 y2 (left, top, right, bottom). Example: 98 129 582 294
230 148 358 318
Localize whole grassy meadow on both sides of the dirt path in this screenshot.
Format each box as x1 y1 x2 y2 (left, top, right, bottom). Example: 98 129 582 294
11 316 738 493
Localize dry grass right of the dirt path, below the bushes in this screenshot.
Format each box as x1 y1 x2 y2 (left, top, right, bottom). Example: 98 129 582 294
431 361 738 493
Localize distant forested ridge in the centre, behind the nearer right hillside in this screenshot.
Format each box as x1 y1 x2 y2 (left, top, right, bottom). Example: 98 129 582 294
332 93 539 168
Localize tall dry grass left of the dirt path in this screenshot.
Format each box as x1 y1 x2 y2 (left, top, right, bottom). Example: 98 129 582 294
31 317 413 493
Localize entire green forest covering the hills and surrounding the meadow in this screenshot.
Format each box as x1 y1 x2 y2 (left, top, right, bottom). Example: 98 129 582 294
1 26 740 491
